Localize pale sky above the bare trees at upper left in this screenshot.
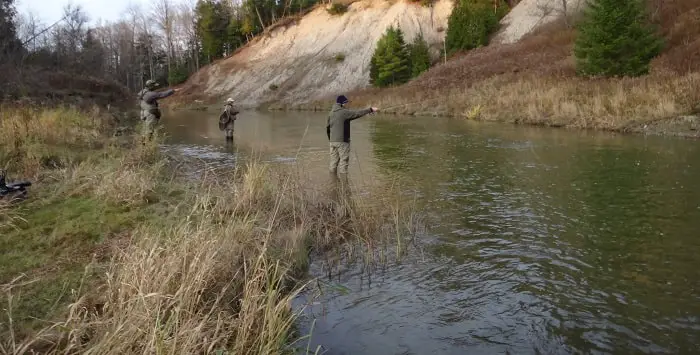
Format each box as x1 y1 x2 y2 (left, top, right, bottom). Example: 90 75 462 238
16 0 147 24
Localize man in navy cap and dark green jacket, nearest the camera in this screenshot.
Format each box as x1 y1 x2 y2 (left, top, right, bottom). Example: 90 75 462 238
326 95 379 174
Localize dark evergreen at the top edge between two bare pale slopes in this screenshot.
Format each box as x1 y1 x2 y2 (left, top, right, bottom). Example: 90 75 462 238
445 0 508 53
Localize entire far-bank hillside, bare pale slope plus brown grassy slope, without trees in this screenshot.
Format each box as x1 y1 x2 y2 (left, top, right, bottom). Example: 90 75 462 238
175 0 700 136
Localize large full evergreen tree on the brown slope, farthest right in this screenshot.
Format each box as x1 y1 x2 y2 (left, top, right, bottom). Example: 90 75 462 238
574 0 663 76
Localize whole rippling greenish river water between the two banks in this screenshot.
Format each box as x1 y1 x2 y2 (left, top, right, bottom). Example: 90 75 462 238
163 110 700 355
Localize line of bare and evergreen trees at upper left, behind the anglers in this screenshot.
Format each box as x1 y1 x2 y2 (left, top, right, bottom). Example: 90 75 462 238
0 0 317 95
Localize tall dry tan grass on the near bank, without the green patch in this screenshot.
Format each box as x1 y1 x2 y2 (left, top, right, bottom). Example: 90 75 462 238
0 107 419 354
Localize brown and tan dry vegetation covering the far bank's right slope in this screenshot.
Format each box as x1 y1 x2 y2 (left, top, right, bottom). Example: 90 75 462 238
284 0 700 135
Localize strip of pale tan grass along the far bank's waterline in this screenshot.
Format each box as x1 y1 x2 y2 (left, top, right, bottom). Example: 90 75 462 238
269 69 700 138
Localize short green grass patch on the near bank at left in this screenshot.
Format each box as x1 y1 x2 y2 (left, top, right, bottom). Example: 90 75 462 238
0 192 153 329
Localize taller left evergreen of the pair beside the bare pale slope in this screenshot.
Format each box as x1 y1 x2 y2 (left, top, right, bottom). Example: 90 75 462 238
370 26 411 87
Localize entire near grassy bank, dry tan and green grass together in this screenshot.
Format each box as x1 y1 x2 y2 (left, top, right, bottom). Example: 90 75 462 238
0 108 414 354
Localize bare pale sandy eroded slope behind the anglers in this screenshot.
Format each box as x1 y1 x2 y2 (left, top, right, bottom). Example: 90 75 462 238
174 0 452 107
